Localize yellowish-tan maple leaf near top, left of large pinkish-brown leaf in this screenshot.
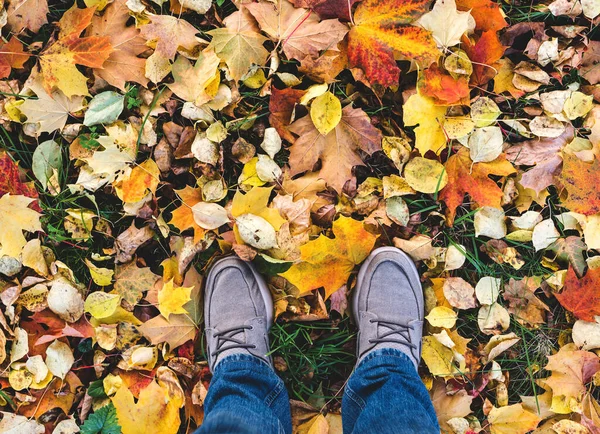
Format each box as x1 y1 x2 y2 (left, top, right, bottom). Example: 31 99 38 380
207 8 269 80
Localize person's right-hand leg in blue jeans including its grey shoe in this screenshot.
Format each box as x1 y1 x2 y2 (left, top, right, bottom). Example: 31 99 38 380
342 247 440 434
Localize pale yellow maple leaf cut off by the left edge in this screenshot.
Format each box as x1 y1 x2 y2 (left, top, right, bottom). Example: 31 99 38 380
0 193 42 258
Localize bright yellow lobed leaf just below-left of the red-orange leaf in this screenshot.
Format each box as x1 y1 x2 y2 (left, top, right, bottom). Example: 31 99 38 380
403 94 446 155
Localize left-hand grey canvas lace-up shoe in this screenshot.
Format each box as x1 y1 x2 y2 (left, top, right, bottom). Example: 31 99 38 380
204 256 273 371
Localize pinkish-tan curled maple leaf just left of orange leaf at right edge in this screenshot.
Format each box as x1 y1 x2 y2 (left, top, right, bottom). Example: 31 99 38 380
506 125 575 194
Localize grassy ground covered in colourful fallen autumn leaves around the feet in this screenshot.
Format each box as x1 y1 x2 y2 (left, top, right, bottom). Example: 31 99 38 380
0 0 600 434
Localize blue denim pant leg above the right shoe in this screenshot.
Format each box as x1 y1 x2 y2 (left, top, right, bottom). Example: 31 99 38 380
342 348 440 434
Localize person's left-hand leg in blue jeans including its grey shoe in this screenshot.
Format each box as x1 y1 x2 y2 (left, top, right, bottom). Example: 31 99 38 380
197 257 292 434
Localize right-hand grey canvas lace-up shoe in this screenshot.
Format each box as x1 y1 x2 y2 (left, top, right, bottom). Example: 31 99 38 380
352 247 424 368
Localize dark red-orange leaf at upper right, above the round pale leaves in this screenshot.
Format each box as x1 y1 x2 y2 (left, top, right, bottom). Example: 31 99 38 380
463 30 505 86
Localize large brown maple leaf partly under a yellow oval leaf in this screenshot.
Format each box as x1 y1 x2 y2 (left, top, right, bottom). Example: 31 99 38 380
289 105 382 192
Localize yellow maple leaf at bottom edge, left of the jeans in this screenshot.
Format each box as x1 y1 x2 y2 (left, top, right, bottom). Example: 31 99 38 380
111 381 182 434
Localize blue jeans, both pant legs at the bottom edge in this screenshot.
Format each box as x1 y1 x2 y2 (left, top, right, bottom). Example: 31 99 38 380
196 348 440 434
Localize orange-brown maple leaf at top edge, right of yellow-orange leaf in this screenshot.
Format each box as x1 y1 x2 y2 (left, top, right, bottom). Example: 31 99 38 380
86 0 148 91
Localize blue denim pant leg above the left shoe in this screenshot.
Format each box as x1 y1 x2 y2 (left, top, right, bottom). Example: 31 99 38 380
195 354 292 434
